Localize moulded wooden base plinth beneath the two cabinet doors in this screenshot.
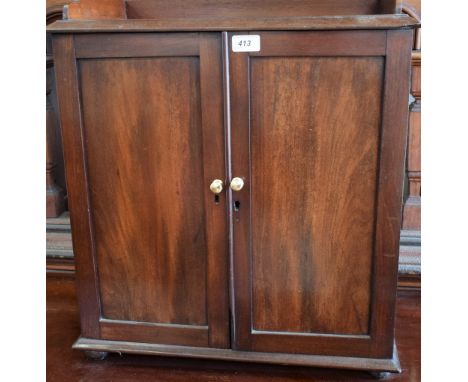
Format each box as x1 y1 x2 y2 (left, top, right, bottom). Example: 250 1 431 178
73 337 401 373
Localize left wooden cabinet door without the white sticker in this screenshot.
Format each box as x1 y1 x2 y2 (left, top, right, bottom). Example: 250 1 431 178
54 33 229 348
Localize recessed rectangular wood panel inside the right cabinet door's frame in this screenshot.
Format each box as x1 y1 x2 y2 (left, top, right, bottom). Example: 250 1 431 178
251 57 384 335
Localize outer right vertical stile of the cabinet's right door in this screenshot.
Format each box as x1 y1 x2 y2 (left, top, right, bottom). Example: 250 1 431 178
372 30 413 357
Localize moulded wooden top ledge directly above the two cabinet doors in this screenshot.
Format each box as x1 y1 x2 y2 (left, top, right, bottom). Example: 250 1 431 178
47 14 419 33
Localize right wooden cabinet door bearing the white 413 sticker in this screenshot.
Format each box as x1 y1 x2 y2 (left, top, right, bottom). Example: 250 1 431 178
229 31 411 358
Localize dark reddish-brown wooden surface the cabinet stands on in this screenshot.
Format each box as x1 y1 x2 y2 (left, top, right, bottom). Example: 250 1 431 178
47 274 421 382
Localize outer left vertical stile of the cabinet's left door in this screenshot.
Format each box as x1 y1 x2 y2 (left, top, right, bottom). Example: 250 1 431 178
53 35 101 338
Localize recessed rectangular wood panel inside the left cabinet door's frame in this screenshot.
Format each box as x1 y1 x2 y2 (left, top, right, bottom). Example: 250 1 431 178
80 57 207 325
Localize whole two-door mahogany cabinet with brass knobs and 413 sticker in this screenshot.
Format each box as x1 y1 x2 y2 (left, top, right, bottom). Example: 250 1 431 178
49 0 416 372
